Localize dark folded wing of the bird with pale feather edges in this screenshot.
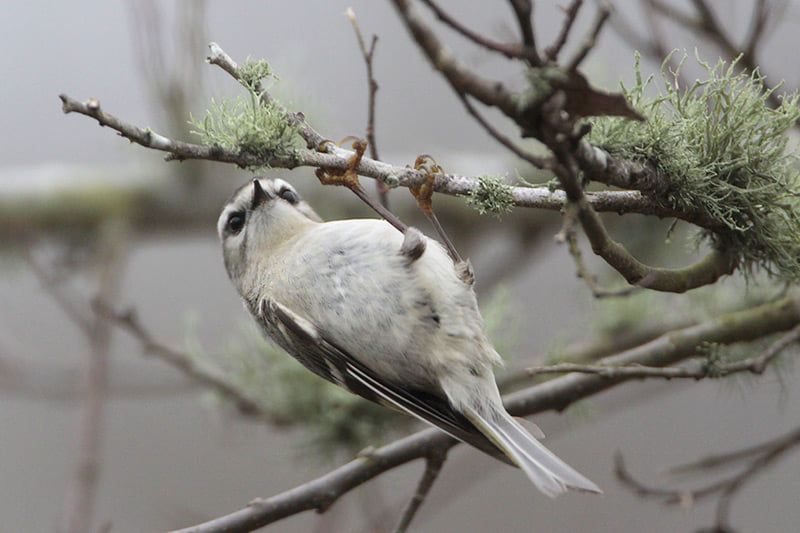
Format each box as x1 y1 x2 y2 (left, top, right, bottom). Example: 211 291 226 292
259 299 508 462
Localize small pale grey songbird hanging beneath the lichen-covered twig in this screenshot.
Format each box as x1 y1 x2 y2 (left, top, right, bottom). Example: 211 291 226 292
217 179 601 496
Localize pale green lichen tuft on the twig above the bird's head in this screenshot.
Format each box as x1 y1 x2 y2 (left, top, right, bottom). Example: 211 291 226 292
190 61 300 168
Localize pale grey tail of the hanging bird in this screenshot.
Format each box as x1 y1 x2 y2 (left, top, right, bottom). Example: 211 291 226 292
464 408 603 497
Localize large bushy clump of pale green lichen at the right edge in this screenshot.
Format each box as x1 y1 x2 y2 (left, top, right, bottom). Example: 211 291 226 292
588 55 800 282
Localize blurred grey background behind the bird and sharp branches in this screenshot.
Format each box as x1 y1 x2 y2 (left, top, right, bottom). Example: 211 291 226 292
0 0 800 533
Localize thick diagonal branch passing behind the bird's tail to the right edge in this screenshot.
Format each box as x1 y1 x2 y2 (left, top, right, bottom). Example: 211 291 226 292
170 298 800 533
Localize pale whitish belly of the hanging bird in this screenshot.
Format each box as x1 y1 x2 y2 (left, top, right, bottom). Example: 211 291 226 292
263 220 496 385
